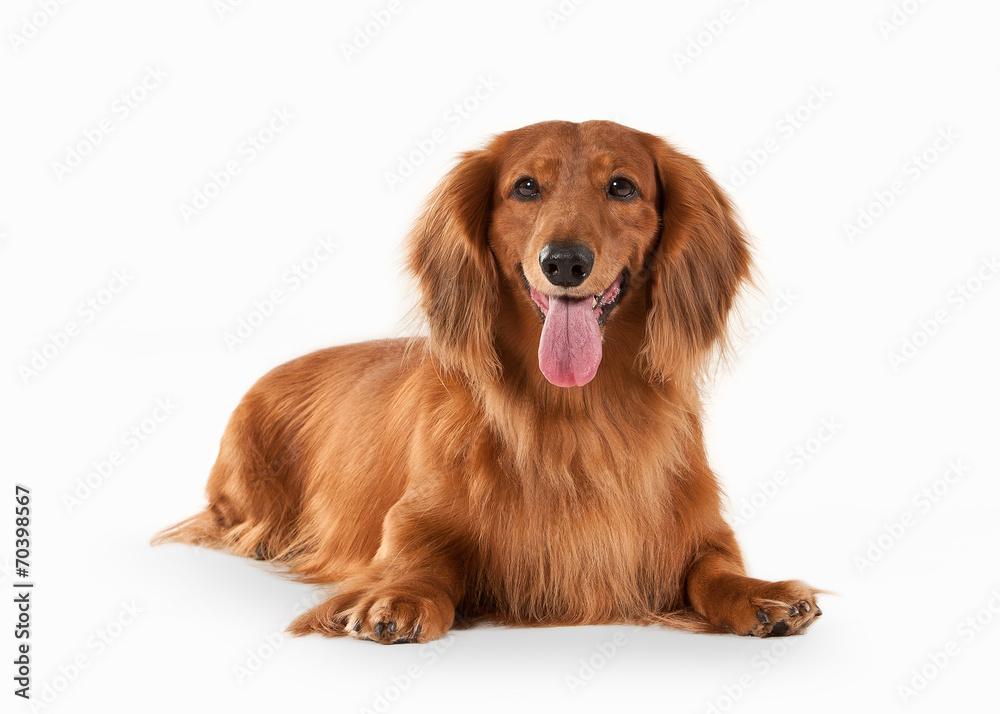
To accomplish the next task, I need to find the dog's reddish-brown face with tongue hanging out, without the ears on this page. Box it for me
[489,122,660,387]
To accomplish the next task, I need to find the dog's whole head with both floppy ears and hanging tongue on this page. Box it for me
[410,121,750,387]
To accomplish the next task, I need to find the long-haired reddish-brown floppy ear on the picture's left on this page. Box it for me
[409,150,500,381]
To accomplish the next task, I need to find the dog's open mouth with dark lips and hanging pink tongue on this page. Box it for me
[518,266,628,387]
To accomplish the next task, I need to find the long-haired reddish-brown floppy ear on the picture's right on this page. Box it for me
[642,137,752,381]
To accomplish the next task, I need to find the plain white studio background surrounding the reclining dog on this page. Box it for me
[0,0,1000,712]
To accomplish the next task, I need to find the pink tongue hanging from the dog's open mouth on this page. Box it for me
[538,295,601,387]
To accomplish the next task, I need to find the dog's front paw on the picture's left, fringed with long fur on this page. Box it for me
[288,593,455,645]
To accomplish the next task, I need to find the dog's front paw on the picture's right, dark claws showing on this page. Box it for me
[705,577,823,637]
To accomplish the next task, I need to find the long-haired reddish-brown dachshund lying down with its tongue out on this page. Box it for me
[157,121,821,643]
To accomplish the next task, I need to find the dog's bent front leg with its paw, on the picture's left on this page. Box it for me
[288,494,467,644]
